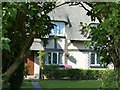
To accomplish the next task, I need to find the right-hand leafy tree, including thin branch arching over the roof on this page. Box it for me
[73,2,120,89]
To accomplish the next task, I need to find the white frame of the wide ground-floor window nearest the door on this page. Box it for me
[45,52,64,65]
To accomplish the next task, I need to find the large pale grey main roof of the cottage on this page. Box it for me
[48,4,98,40]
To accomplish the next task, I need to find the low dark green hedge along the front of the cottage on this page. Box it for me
[43,65,111,80]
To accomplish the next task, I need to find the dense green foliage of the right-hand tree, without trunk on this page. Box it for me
[91,2,120,69]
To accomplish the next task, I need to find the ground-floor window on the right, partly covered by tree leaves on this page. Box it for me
[91,52,100,66]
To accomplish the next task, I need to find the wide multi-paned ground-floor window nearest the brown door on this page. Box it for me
[45,52,63,65]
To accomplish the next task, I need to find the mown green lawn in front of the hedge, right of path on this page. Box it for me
[39,80,101,90]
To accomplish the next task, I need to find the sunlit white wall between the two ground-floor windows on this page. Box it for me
[68,41,90,69]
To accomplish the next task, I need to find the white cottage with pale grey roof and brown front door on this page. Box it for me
[26,4,112,78]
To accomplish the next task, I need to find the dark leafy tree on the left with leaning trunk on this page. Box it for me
[2,2,55,90]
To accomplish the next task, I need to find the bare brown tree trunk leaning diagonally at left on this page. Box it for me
[3,32,35,82]
